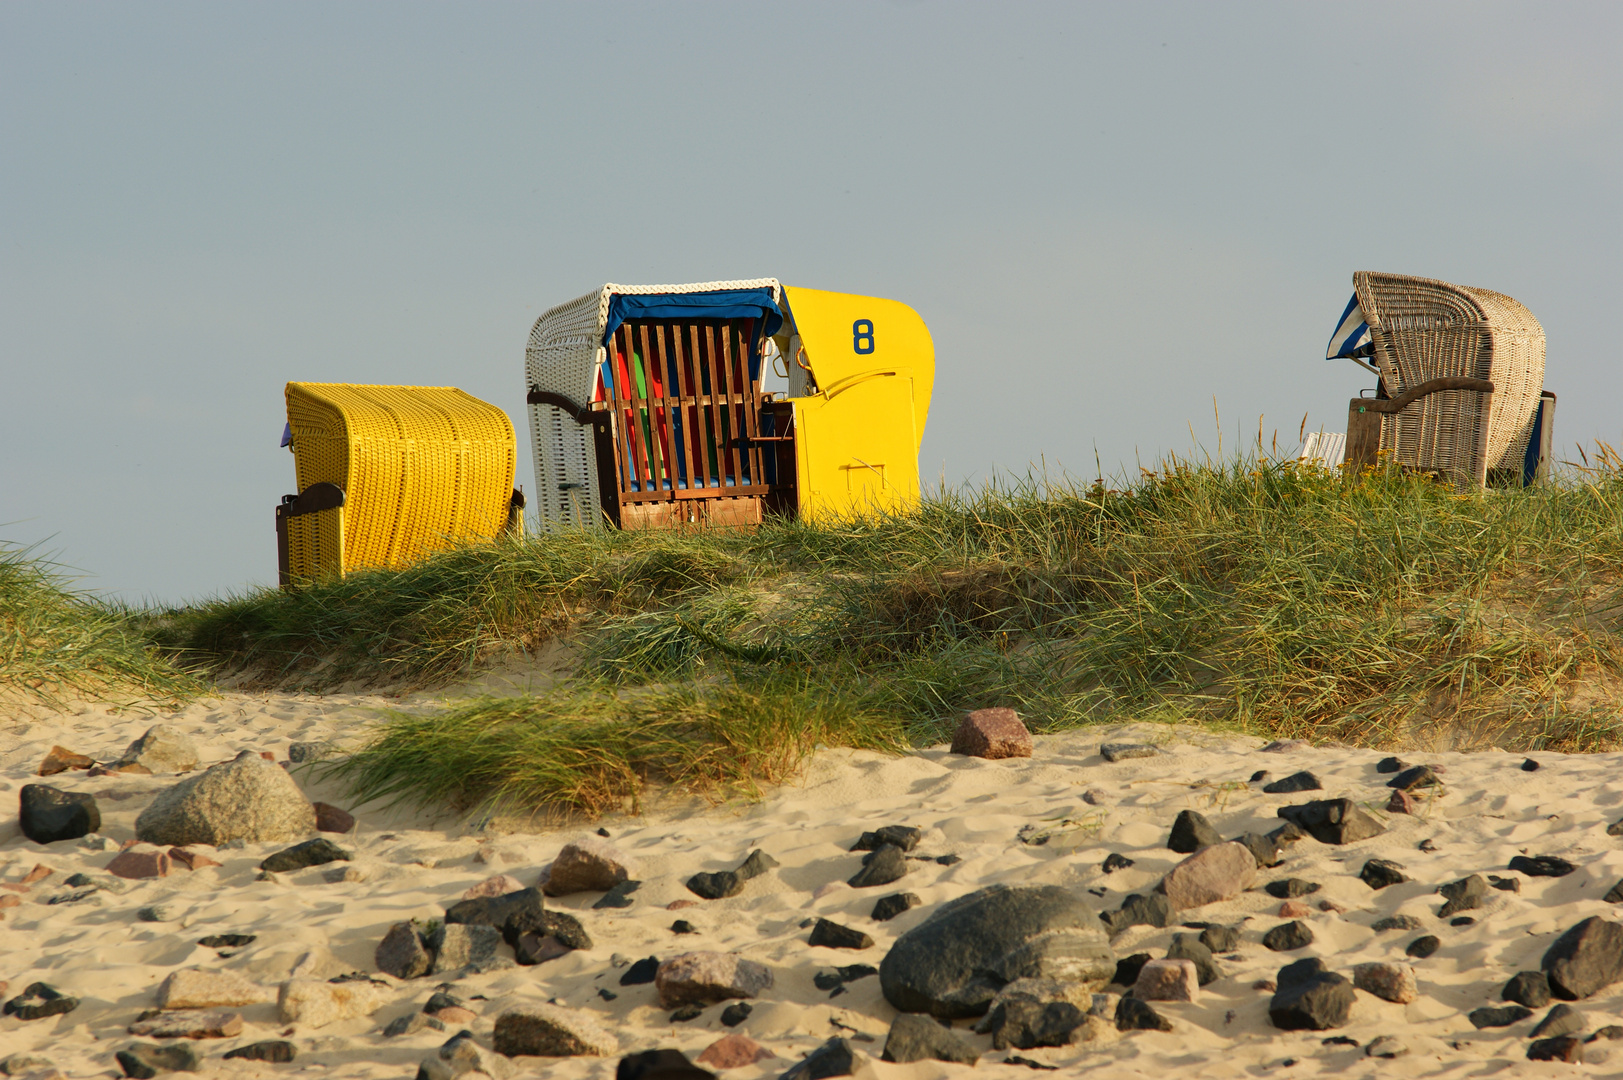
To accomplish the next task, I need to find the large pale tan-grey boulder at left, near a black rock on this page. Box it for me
[135,750,315,848]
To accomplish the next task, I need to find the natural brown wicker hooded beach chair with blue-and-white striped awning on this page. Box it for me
[1326,271,1555,487]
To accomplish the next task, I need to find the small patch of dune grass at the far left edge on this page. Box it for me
[0,541,201,703]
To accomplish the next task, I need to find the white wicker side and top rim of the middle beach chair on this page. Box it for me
[524,278,782,533]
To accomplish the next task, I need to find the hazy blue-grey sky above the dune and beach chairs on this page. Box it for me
[0,0,1623,604]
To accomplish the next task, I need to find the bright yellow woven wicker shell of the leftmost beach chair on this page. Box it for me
[287,383,518,577]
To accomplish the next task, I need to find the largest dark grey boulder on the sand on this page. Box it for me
[880,885,1115,1020]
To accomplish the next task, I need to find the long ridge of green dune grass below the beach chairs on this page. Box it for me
[166,456,1623,810]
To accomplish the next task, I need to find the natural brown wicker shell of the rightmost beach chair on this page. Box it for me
[1352,271,1543,484]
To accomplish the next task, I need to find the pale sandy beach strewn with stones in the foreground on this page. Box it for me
[0,693,1623,1080]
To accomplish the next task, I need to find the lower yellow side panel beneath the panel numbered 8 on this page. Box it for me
[792,372,919,521]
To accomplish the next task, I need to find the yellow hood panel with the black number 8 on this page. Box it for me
[784,286,935,444]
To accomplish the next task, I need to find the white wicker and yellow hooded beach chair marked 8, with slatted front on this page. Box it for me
[524,278,935,529]
